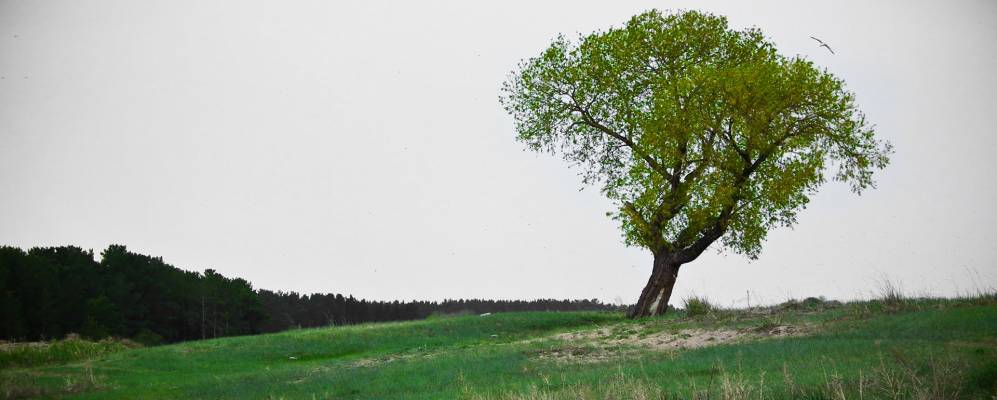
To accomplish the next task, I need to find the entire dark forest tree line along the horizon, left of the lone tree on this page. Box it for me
[0,245,616,344]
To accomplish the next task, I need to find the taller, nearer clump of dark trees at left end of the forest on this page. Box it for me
[0,245,264,344]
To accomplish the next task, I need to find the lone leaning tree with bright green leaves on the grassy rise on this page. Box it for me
[501,11,892,317]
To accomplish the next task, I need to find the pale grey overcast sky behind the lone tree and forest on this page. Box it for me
[0,0,997,306]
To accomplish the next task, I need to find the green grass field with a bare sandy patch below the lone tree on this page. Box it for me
[0,295,997,399]
